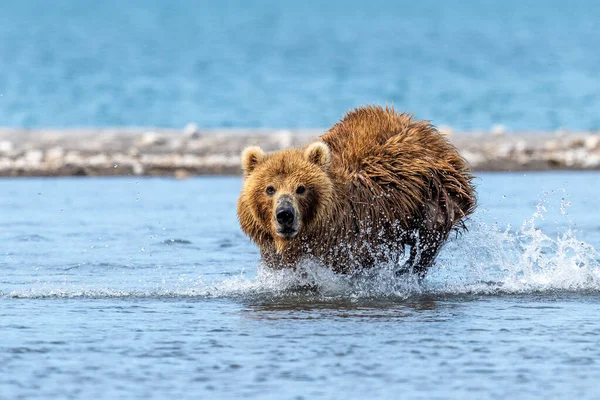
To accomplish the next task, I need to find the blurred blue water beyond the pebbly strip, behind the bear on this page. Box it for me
[0,0,600,130]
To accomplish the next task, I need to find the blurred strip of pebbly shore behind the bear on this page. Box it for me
[0,125,600,178]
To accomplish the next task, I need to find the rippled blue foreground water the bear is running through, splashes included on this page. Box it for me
[0,173,600,399]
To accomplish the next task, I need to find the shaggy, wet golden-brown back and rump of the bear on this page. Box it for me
[320,106,475,236]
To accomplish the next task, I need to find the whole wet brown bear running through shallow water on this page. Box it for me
[237,106,476,277]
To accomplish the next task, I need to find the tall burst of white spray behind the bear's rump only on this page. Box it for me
[428,217,600,294]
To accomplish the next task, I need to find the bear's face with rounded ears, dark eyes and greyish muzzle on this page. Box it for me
[238,142,333,241]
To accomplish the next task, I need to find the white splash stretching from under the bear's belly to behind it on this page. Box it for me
[190,190,600,298]
